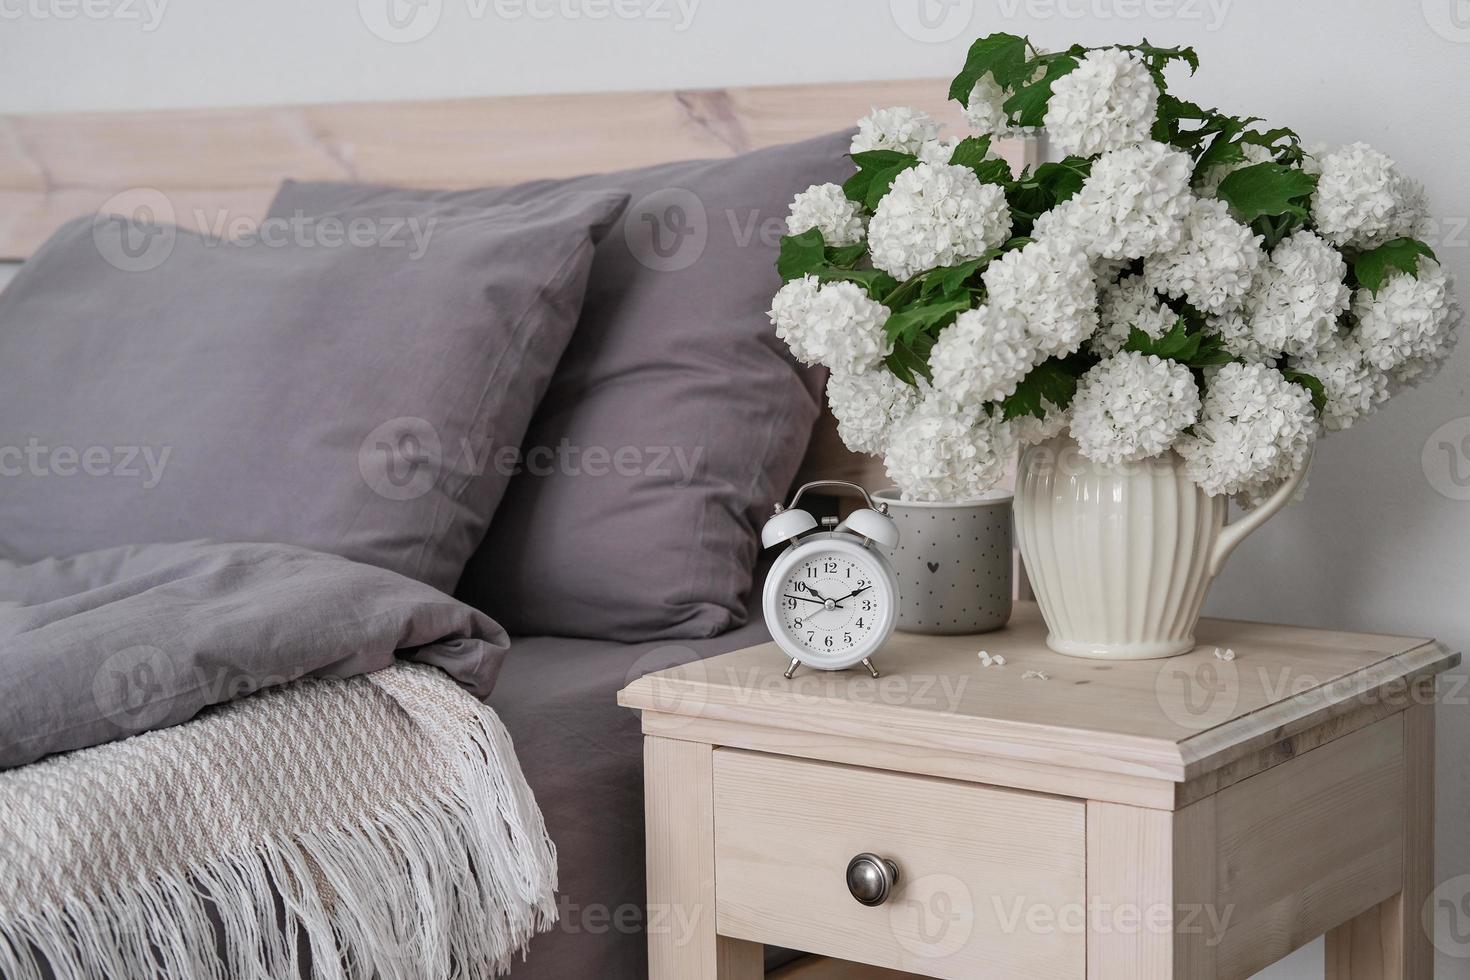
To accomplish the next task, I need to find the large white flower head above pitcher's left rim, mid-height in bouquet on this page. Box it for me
[980,238,1098,361]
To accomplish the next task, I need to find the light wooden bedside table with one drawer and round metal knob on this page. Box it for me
[619,602,1460,980]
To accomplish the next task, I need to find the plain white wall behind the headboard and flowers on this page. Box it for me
[0,0,1470,980]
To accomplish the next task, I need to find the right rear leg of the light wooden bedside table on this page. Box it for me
[1326,702,1435,980]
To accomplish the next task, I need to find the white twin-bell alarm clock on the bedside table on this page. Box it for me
[760,480,898,679]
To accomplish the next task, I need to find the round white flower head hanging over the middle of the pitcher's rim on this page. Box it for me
[1072,351,1200,463]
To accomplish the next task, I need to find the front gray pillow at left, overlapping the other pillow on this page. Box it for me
[0,191,628,591]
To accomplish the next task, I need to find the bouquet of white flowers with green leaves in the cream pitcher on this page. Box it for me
[770,34,1460,500]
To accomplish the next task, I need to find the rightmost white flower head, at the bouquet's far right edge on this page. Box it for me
[1352,257,1460,372]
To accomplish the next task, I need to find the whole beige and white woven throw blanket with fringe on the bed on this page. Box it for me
[0,664,556,980]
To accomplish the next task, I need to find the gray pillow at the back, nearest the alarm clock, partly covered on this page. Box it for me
[270,134,851,641]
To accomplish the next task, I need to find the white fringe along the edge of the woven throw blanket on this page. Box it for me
[0,690,557,980]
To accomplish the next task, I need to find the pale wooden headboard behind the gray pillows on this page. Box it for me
[0,79,1032,488]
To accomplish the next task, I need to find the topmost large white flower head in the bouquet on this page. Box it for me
[1044,48,1158,157]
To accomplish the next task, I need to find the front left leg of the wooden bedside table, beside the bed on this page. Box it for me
[644,736,764,980]
